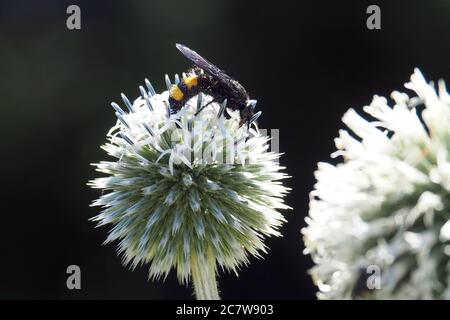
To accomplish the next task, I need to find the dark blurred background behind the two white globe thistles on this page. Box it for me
[0,0,450,299]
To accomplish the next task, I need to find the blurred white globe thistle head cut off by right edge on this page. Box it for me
[302,69,450,299]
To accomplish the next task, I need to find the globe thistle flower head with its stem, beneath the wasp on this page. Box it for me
[90,76,288,299]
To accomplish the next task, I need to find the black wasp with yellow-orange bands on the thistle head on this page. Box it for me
[169,44,261,126]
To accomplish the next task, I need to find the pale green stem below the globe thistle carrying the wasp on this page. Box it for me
[191,253,220,300]
